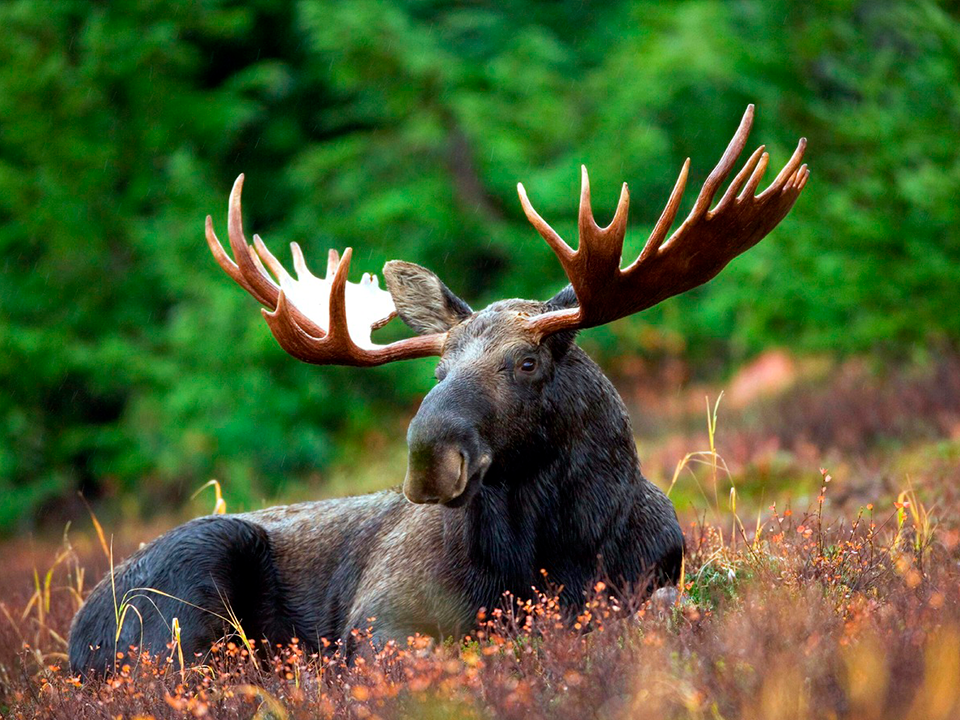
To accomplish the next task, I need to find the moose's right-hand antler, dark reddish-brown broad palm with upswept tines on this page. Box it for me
[517,105,810,335]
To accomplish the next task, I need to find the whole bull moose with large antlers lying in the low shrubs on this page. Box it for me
[69,105,809,676]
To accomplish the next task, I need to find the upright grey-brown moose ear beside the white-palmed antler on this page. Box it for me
[383,260,473,335]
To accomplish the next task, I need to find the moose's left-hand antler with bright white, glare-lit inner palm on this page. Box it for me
[207,175,445,366]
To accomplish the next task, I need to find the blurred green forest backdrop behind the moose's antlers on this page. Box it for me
[0,0,960,531]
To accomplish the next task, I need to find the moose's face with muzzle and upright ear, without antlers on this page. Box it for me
[384,262,569,507]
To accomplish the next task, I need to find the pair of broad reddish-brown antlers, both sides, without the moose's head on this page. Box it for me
[207,105,810,366]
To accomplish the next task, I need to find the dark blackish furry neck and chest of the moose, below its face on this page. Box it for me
[447,346,641,602]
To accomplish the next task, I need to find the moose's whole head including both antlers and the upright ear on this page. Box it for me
[206,105,809,506]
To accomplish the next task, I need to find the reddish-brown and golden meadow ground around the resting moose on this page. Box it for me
[0,353,960,720]
